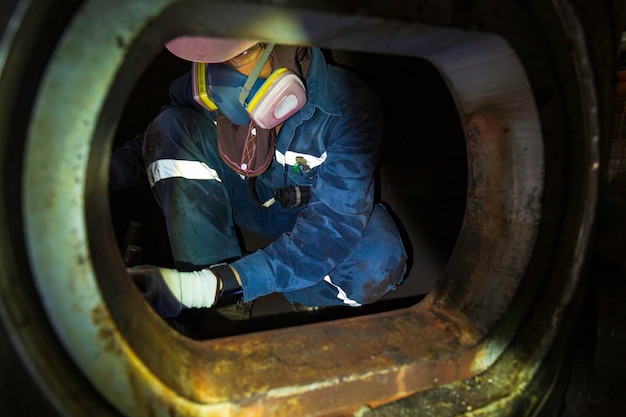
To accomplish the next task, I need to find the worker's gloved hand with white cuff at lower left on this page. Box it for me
[128,265,221,317]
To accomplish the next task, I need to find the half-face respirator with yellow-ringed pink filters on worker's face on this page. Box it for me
[191,44,306,129]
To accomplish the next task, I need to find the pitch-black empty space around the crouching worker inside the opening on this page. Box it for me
[111,45,467,338]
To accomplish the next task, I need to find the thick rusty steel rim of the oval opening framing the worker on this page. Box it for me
[1,0,608,417]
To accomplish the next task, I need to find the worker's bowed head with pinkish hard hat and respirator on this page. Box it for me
[166,37,306,129]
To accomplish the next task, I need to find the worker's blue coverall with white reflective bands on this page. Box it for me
[143,48,406,306]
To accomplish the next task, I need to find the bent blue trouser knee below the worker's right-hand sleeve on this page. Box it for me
[284,205,407,306]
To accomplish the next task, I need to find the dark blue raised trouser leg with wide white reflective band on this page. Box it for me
[143,107,241,270]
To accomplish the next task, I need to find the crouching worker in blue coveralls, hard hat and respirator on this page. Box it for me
[121,37,406,317]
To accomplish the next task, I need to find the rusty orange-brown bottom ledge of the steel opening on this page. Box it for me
[152,304,485,415]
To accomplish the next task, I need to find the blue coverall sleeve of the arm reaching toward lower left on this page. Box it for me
[232,77,383,301]
